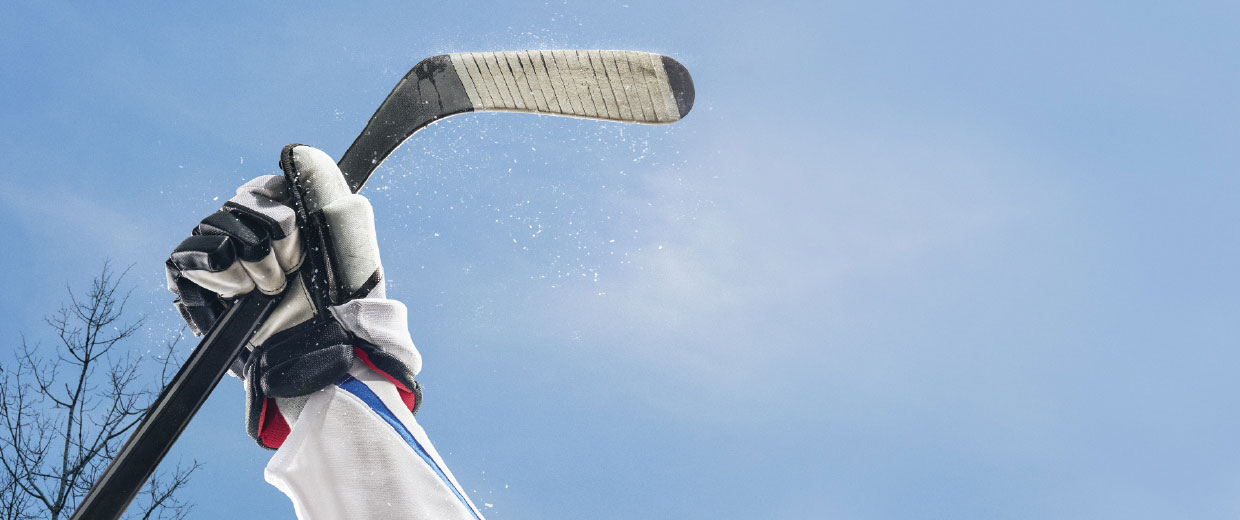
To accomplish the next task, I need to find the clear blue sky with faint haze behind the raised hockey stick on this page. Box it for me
[0,0,1240,519]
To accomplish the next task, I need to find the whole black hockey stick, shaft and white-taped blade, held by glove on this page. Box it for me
[73,51,694,520]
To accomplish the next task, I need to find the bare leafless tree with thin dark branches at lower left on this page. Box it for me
[0,263,198,520]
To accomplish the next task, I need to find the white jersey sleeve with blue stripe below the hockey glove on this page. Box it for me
[265,361,482,520]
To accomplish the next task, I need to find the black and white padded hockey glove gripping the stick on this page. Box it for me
[166,144,422,448]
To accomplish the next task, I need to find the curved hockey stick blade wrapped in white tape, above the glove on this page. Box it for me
[340,51,694,192]
